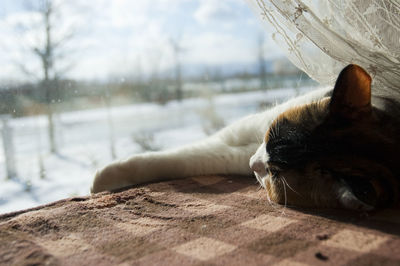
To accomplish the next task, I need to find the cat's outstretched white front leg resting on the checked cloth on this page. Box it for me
[91,138,257,193]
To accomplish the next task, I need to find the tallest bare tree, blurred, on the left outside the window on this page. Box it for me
[18,0,74,153]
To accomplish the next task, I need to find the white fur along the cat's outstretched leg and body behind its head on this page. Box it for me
[92,88,329,193]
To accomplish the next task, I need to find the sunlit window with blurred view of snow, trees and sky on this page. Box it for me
[0,0,316,213]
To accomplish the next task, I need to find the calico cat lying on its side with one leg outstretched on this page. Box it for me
[92,65,400,210]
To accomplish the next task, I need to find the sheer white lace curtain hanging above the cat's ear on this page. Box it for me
[248,0,400,96]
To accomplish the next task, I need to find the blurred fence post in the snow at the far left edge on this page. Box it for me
[0,115,17,179]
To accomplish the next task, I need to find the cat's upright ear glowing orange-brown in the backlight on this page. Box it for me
[329,65,372,119]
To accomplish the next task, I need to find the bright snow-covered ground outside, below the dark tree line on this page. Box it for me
[0,88,318,213]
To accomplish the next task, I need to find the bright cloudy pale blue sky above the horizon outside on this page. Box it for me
[0,0,282,83]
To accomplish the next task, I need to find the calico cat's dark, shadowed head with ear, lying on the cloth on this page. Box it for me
[250,65,399,210]
